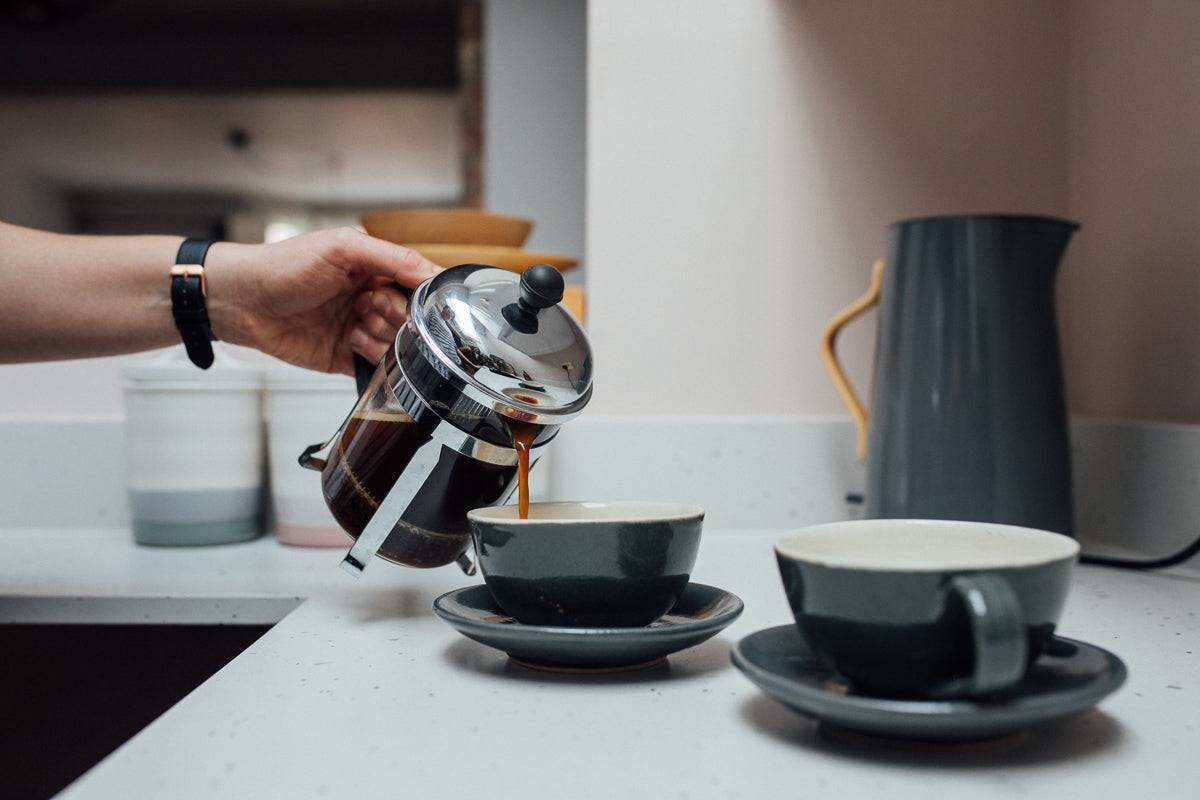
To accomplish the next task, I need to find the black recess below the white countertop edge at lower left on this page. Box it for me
[0,625,269,800]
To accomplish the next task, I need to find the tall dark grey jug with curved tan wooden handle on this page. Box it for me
[822,215,1079,535]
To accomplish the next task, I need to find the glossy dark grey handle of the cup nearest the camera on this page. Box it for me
[950,573,1028,694]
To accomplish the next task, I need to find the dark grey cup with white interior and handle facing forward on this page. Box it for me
[775,519,1079,698]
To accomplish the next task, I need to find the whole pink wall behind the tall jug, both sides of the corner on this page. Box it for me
[588,0,1200,422]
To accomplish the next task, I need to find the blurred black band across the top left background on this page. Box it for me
[0,0,460,92]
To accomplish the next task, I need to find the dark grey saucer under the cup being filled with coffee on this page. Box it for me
[433,583,743,672]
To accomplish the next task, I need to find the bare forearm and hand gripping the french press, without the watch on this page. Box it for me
[0,223,438,373]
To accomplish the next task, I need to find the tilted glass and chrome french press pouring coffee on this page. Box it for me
[300,264,592,576]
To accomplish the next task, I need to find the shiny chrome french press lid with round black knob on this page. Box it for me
[409,264,592,421]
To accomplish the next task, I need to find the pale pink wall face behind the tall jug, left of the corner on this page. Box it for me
[588,0,1069,415]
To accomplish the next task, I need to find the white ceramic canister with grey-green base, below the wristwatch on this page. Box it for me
[124,343,264,545]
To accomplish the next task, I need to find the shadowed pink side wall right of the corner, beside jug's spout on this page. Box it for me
[1060,0,1200,422]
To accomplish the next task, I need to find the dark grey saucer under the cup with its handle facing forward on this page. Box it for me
[732,625,1126,740]
